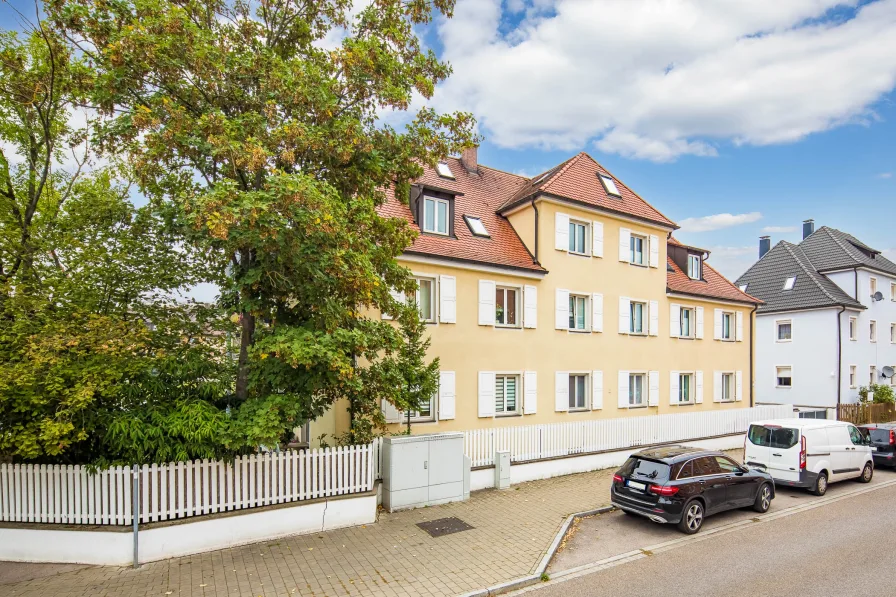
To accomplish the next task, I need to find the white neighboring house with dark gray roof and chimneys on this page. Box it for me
[736,220,896,416]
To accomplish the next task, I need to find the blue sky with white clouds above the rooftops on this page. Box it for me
[0,0,896,286]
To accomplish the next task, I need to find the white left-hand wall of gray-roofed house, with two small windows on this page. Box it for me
[756,309,845,406]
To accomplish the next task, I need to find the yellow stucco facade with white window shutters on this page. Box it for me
[311,198,753,437]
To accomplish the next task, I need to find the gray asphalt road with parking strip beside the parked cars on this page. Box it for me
[519,471,896,597]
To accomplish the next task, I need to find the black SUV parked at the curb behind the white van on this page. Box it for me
[610,446,775,535]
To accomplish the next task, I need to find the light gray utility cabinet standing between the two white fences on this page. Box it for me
[383,433,470,512]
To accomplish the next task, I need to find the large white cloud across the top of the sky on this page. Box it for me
[434,0,896,161]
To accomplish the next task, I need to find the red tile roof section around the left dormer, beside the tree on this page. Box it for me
[380,158,545,272]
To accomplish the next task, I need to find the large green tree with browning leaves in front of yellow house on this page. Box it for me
[47,0,474,448]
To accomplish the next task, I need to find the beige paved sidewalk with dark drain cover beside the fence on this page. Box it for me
[0,470,612,597]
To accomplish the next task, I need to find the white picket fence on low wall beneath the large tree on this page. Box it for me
[0,444,379,525]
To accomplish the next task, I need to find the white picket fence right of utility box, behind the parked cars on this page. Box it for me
[464,405,794,467]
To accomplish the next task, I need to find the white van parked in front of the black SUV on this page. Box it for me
[744,419,874,495]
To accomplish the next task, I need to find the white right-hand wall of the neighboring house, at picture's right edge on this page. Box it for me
[828,270,896,402]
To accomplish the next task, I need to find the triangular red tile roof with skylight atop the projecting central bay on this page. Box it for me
[501,152,677,228]
